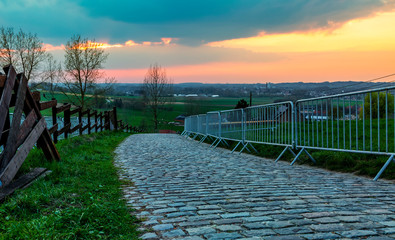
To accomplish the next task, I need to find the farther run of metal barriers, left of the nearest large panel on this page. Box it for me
[184,102,296,158]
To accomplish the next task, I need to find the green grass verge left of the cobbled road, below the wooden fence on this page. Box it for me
[0,131,138,239]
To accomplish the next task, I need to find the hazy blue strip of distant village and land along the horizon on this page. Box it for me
[111,81,394,100]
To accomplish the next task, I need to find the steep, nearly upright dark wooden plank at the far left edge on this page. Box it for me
[0,66,16,141]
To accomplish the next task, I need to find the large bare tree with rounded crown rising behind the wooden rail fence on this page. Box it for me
[62,35,115,109]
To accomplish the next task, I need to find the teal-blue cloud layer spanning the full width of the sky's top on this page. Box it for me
[0,0,395,45]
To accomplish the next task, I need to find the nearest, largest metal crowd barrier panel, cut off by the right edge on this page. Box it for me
[291,87,395,180]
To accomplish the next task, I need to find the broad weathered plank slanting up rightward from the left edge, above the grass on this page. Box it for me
[0,118,46,186]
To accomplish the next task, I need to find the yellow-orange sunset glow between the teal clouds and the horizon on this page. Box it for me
[44,11,395,83]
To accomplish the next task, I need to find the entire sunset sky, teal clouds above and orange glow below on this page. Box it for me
[0,0,395,83]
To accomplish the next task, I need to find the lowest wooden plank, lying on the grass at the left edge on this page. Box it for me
[0,168,47,202]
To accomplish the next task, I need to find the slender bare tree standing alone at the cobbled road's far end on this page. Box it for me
[143,64,172,130]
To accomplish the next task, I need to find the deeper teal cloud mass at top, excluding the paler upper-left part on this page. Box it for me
[74,0,394,43]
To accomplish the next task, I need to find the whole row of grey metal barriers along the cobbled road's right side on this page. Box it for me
[183,87,395,180]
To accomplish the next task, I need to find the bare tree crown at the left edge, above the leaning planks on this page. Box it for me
[0,27,48,88]
